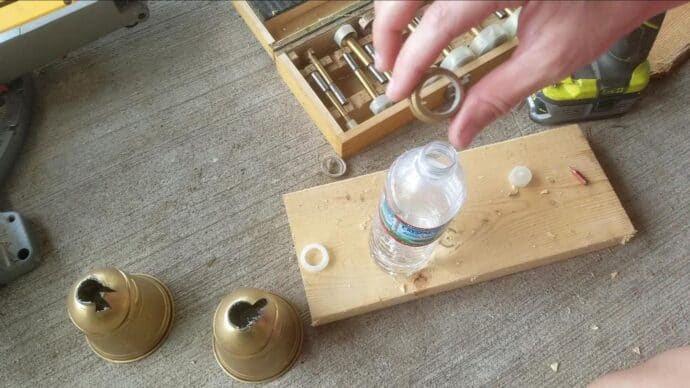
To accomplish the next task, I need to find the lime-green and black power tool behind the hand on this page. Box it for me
[527,13,665,124]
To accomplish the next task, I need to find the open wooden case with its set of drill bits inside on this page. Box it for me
[232,0,518,158]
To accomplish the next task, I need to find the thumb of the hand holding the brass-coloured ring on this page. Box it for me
[448,49,565,148]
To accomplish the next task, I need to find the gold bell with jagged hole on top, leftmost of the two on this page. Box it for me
[67,268,174,363]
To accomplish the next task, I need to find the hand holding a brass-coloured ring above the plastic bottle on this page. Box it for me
[373,0,683,148]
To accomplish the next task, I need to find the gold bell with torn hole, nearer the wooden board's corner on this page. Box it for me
[213,288,304,383]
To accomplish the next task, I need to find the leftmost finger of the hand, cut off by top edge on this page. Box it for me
[372,0,424,71]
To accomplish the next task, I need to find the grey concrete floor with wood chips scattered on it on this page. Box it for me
[0,1,690,387]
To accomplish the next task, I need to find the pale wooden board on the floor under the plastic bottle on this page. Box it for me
[284,125,635,326]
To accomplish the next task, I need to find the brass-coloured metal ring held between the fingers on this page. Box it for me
[409,67,462,123]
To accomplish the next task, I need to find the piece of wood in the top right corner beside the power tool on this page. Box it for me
[649,3,690,77]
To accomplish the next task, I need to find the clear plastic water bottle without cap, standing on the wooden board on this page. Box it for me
[369,141,467,275]
